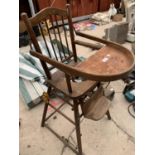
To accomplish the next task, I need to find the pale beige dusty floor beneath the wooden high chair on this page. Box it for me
[19,20,135,155]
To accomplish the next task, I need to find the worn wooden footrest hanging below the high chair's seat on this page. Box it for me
[81,87,110,121]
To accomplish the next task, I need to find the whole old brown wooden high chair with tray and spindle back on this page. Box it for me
[22,5,134,155]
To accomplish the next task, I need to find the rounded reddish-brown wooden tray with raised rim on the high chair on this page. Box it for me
[76,44,134,81]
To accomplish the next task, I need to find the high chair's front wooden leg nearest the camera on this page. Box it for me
[74,101,82,155]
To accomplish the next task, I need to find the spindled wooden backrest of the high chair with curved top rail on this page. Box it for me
[21,4,77,79]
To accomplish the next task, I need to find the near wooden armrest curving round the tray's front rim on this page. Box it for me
[30,48,134,81]
